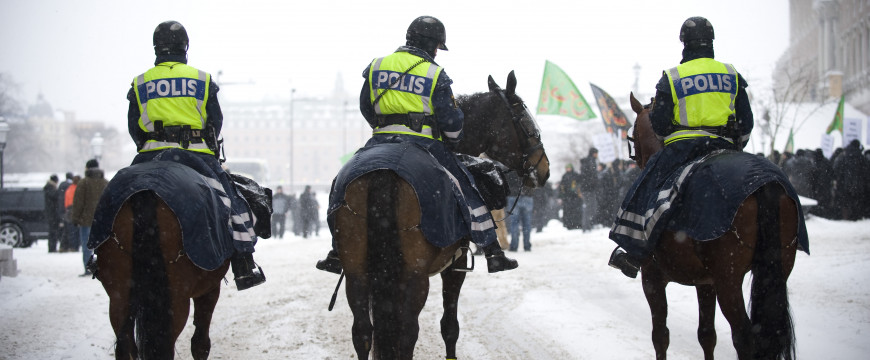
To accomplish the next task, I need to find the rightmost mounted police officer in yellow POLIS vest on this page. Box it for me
[609,16,753,278]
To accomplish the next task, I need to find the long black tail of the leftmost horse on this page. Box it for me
[129,191,175,360]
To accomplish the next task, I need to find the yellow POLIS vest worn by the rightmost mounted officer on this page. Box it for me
[665,58,738,145]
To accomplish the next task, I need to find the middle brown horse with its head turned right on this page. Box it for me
[335,72,549,360]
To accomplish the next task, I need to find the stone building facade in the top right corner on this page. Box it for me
[774,0,870,113]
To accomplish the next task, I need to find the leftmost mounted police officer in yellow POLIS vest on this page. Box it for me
[127,21,266,290]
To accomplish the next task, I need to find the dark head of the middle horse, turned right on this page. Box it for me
[482,71,550,188]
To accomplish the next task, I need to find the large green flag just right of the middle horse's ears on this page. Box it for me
[537,61,595,120]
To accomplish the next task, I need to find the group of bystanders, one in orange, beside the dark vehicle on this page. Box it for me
[42,159,108,276]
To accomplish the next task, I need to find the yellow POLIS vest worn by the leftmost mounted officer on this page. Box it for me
[134,62,214,154]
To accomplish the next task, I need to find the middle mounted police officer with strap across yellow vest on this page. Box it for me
[317,16,518,273]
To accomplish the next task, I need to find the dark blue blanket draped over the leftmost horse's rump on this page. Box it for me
[88,161,235,271]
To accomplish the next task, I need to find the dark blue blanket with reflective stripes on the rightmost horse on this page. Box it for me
[610,150,809,256]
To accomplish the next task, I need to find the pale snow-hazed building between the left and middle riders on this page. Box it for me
[221,92,371,193]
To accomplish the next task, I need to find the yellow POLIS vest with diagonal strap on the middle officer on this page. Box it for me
[368,52,442,139]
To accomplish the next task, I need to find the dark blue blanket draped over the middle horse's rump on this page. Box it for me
[326,142,471,247]
